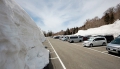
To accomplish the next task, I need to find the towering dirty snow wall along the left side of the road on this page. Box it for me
[0,0,49,69]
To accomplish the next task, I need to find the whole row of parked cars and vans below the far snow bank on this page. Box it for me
[53,35,120,54]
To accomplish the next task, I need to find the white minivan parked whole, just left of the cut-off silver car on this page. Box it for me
[83,37,107,47]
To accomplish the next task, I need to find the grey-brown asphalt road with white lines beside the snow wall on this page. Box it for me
[43,38,120,69]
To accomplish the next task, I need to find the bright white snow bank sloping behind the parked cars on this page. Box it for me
[75,20,120,37]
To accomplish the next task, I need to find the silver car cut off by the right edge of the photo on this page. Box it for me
[106,36,120,54]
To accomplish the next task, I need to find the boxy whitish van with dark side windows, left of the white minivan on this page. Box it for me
[67,35,83,43]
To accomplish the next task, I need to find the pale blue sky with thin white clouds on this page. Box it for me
[15,0,120,32]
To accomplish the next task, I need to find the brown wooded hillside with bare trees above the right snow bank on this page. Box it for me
[79,4,120,30]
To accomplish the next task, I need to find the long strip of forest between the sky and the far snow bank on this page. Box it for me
[43,3,120,37]
